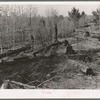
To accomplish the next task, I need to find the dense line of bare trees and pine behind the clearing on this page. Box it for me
[0,5,94,53]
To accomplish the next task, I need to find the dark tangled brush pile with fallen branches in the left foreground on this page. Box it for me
[0,42,68,89]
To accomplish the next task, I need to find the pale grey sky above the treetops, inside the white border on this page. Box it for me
[38,4,99,16]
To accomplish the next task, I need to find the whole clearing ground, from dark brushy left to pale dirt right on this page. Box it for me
[0,37,100,89]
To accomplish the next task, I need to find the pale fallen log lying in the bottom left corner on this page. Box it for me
[1,80,36,89]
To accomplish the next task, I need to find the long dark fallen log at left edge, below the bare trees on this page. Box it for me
[0,45,31,59]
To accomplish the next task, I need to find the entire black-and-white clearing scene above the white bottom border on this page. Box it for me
[0,2,100,89]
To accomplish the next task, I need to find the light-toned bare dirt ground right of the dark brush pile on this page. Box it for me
[43,38,100,89]
